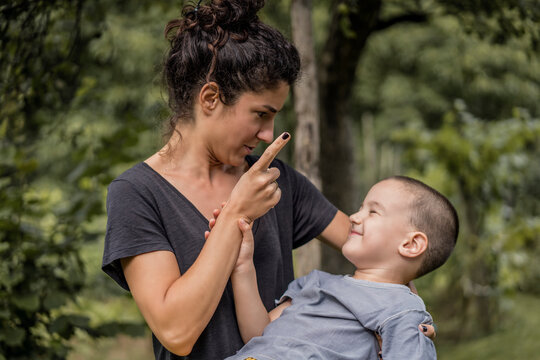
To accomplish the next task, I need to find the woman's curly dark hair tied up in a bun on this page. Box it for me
[163,0,300,137]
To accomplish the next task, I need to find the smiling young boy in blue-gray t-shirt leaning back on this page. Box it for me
[221,176,459,360]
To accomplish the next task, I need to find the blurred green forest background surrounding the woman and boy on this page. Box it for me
[0,0,540,360]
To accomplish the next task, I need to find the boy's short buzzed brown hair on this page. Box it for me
[387,176,459,277]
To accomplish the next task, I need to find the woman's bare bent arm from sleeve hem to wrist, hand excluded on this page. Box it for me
[122,210,242,355]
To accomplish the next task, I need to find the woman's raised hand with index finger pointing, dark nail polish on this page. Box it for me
[227,133,291,223]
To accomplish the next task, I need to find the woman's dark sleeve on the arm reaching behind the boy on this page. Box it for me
[292,166,337,248]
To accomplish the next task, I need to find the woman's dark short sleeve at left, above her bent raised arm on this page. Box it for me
[102,180,173,290]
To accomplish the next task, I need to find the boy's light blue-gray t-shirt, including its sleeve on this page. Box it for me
[227,270,437,360]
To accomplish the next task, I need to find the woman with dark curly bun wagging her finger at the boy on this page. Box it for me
[103,0,430,360]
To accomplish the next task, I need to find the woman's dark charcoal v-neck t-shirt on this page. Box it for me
[102,156,337,360]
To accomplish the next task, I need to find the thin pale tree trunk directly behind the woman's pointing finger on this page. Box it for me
[291,0,321,276]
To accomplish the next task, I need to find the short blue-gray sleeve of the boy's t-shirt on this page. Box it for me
[377,310,437,360]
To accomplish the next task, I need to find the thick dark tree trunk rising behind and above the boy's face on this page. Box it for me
[319,0,381,273]
